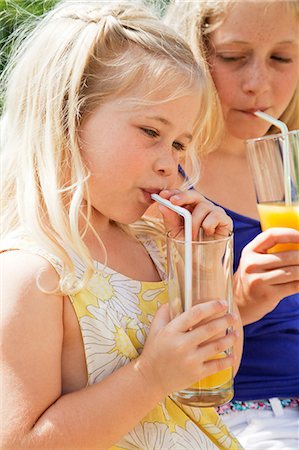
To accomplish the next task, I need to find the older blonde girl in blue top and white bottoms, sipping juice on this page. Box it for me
[167,0,299,450]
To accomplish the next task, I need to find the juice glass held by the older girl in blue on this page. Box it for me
[245,130,299,252]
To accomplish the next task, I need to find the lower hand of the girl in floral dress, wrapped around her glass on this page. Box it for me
[137,301,237,397]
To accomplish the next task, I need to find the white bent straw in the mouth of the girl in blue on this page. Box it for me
[254,111,292,206]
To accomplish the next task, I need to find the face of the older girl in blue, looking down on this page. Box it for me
[210,1,299,140]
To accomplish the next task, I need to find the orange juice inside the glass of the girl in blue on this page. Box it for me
[258,202,299,253]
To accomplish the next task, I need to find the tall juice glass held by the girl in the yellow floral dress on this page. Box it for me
[167,228,234,407]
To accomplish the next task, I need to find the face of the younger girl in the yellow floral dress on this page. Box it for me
[79,82,200,224]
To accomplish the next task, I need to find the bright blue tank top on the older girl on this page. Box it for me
[220,208,299,400]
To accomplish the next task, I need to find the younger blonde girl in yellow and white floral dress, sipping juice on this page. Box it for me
[0,1,241,450]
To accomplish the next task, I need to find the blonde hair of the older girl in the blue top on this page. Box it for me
[165,0,299,134]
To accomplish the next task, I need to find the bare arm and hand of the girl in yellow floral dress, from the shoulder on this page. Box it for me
[0,252,235,450]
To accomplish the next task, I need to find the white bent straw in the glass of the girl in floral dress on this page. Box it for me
[151,194,192,311]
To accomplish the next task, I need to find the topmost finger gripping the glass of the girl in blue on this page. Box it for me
[248,228,299,253]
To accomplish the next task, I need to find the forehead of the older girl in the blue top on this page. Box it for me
[212,0,299,43]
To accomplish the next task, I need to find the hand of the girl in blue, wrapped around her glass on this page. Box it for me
[234,228,299,325]
